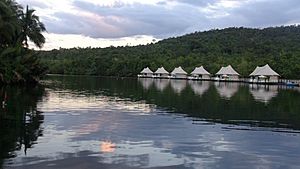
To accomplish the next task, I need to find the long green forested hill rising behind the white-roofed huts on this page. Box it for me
[39,26,300,79]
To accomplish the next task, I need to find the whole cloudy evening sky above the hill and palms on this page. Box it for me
[17,0,300,50]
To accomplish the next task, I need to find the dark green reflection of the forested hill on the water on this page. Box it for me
[45,76,300,129]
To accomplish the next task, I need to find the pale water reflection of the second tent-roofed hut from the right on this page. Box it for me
[215,82,239,99]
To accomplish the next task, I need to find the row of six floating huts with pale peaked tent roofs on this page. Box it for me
[138,64,299,85]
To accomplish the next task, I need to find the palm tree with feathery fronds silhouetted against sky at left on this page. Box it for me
[19,5,46,48]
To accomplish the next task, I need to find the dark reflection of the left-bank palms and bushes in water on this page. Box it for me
[0,86,44,166]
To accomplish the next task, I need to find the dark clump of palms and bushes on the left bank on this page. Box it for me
[0,0,46,85]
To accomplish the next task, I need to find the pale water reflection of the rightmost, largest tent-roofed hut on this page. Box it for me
[250,85,278,103]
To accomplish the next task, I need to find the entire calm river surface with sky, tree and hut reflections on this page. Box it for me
[0,76,300,169]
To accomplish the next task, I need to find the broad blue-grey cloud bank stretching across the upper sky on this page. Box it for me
[44,0,300,38]
